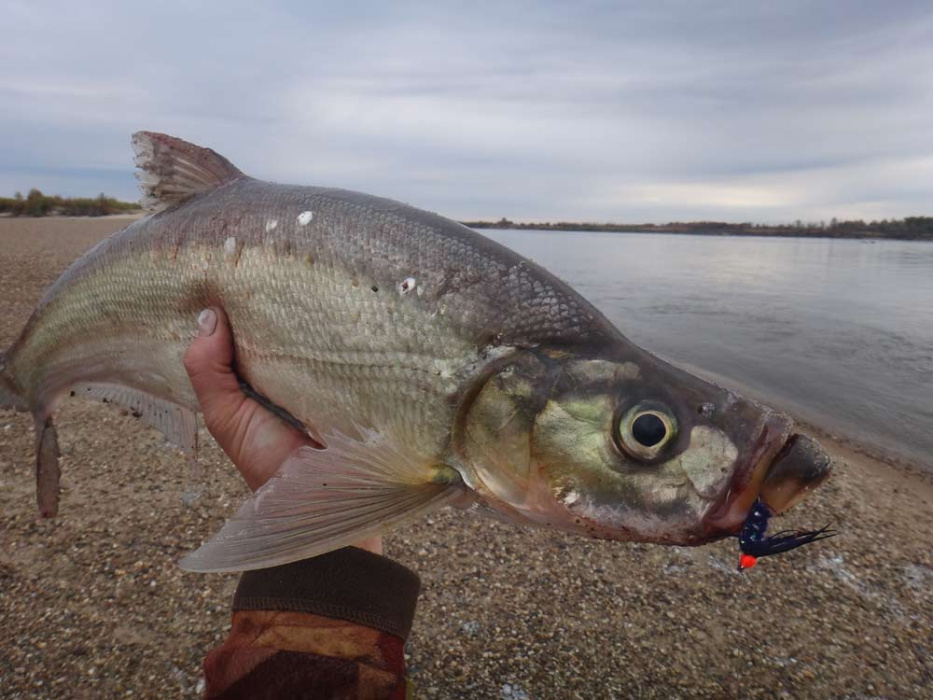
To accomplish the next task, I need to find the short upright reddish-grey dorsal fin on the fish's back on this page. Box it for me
[133,131,245,211]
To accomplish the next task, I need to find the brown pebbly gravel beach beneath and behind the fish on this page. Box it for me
[0,218,933,700]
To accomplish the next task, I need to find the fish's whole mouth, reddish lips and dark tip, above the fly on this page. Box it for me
[702,413,833,538]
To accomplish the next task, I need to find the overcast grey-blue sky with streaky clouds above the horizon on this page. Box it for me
[0,0,933,223]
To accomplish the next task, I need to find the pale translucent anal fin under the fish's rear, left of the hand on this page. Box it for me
[72,383,198,458]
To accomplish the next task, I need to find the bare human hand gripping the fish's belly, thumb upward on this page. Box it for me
[184,308,382,554]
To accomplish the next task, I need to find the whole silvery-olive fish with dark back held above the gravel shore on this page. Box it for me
[0,131,832,572]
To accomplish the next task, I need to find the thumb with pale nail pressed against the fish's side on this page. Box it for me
[184,308,247,445]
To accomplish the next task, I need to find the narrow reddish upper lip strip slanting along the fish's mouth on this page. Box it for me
[701,411,792,537]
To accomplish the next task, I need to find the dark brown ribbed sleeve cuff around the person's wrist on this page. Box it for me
[233,547,421,639]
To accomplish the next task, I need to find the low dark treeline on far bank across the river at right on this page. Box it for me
[462,216,933,240]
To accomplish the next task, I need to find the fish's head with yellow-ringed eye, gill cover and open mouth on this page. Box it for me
[459,345,832,545]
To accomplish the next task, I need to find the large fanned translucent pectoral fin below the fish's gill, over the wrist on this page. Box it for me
[180,430,464,572]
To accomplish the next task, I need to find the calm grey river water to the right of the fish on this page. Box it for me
[481,230,933,470]
